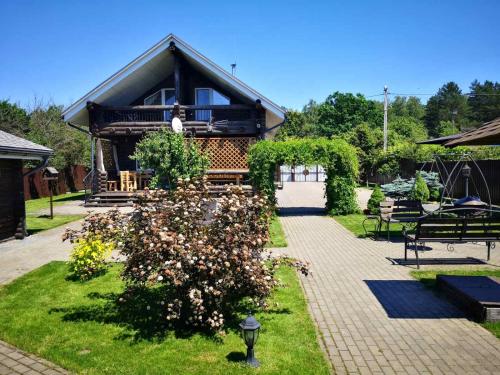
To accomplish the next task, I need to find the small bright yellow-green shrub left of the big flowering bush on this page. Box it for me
[69,238,114,280]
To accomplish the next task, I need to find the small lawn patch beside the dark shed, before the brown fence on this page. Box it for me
[26,192,85,234]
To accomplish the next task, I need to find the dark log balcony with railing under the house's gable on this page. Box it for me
[87,102,265,136]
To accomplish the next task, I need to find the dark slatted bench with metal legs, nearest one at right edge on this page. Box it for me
[403,208,500,268]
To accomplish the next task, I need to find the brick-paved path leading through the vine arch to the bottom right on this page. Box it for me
[278,183,500,374]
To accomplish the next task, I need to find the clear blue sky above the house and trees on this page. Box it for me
[0,0,500,108]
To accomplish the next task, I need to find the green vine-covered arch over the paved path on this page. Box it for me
[248,138,358,215]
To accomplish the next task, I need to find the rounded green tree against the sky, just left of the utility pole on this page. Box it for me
[317,91,383,137]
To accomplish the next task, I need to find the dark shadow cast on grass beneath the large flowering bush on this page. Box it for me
[49,286,291,342]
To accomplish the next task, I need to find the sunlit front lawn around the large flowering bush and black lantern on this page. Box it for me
[0,262,329,374]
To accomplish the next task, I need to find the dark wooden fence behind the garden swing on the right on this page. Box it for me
[368,160,500,205]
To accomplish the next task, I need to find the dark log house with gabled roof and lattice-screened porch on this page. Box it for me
[63,34,285,204]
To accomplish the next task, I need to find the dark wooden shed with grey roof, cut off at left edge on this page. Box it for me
[0,130,53,241]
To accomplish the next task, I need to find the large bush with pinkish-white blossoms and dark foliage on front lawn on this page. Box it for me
[66,179,307,330]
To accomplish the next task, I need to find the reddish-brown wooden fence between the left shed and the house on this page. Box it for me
[23,165,88,200]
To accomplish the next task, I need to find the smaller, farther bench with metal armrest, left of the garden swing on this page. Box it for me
[377,199,424,241]
